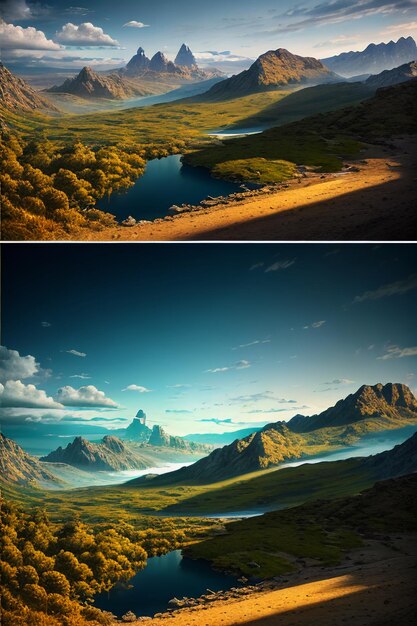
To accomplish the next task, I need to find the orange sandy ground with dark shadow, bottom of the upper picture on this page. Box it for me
[77,138,417,241]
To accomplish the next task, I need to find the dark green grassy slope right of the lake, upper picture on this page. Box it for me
[186,81,417,182]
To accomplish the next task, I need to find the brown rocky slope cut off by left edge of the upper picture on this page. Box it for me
[0,63,58,111]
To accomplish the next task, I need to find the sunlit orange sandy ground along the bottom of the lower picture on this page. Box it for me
[135,535,417,626]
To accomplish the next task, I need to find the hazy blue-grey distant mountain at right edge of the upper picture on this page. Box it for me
[321,37,417,77]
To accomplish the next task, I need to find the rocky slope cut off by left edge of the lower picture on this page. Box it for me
[0,433,60,484]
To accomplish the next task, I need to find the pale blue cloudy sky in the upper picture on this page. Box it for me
[0,0,417,73]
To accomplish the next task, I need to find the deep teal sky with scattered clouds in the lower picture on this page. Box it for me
[0,244,417,435]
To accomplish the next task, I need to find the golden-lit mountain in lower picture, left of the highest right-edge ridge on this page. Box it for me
[131,422,304,485]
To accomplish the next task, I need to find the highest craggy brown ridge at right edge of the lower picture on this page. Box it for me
[288,383,417,433]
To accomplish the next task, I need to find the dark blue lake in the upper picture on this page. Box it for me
[97,154,250,221]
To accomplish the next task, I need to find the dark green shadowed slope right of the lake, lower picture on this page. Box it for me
[187,474,417,578]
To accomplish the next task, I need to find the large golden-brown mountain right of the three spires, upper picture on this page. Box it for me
[201,48,339,100]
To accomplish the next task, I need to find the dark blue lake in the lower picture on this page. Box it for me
[94,550,238,617]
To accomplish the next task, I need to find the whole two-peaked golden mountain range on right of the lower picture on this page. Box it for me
[132,383,417,485]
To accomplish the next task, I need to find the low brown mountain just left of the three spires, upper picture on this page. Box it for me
[47,67,152,100]
